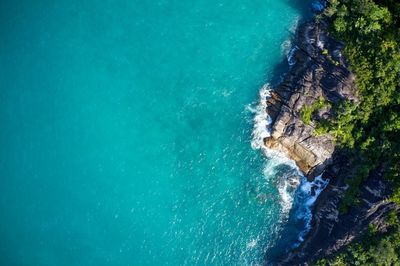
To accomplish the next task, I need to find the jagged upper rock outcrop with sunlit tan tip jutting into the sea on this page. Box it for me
[265,20,357,178]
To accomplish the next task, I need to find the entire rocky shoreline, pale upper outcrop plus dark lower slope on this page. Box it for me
[264,11,397,265]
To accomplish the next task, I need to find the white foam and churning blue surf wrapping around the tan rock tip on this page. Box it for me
[250,84,329,246]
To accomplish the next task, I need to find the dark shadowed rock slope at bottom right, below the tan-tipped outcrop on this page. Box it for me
[280,151,399,265]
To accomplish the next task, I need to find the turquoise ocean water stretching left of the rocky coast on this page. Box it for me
[0,0,309,266]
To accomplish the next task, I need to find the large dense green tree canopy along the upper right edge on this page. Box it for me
[317,0,400,211]
